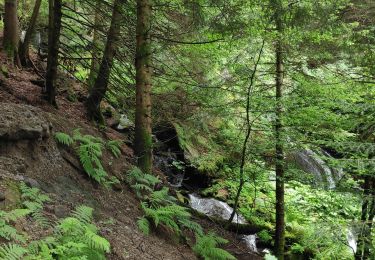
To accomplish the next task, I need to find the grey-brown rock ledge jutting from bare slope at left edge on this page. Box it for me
[0,103,52,141]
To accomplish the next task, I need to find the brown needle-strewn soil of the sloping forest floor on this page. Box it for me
[0,41,261,259]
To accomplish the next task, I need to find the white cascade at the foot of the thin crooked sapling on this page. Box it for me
[189,194,247,224]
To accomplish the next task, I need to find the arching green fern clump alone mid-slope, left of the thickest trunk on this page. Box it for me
[55,129,121,187]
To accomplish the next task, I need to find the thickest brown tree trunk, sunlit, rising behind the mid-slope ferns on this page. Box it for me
[134,0,152,173]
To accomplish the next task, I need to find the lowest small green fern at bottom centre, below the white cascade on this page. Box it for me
[193,233,236,260]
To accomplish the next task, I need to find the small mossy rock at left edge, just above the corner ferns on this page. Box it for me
[0,179,22,211]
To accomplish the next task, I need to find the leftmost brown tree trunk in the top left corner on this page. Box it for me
[3,0,20,65]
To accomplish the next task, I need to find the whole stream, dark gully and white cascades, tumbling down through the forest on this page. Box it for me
[154,126,357,255]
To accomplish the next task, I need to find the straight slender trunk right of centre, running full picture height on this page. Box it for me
[273,0,285,260]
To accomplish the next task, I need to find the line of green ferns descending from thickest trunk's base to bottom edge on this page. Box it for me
[127,168,236,260]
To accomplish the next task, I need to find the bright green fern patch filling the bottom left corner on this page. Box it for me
[0,183,110,260]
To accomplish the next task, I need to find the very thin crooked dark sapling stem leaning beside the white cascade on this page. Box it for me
[228,40,264,223]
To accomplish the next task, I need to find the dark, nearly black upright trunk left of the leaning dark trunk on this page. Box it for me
[45,0,62,107]
